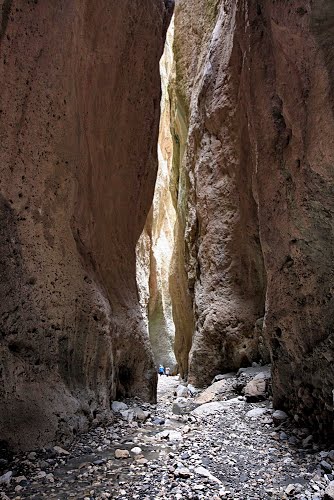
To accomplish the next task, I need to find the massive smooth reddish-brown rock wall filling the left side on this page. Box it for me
[0,0,172,448]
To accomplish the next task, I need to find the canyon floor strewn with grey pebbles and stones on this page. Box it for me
[0,374,334,500]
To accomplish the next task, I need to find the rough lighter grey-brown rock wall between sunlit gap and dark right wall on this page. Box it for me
[176,1,265,385]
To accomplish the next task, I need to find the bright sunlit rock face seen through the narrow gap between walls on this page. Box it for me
[137,17,177,372]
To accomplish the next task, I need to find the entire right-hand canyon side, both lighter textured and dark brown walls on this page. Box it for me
[175,0,334,436]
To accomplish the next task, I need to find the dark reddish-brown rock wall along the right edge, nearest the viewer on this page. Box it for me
[244,1,334,436]
